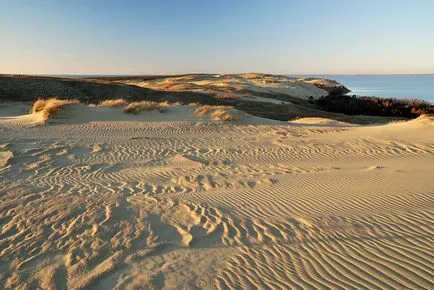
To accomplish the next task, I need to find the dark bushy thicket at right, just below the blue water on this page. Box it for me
[315,95,434,118]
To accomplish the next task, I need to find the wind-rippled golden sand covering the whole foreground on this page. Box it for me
[0,104,434,289]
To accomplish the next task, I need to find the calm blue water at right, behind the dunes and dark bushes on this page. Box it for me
[292,75,434,102]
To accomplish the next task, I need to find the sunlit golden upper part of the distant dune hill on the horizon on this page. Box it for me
[117,73,342,102]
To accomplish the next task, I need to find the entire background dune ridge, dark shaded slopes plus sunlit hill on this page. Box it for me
[0,74,402,124]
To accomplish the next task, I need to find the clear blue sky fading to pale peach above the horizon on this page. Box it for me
[0,0,434,74]
